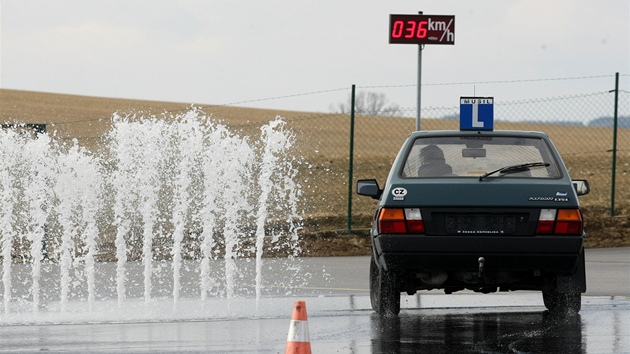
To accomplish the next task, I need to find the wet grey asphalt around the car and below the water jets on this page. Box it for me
[0,248,630,353]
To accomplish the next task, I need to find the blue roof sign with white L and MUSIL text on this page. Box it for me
[459,97,494,130]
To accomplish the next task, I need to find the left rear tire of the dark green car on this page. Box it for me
[370,258,400,316]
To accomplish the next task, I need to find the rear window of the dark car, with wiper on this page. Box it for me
[400,136,560,178]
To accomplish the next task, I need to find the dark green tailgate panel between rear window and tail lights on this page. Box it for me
[381,178,579,208]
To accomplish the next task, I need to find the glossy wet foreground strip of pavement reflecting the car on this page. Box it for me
[0,299,630,353]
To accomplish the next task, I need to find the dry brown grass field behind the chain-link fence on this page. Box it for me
[0,89,630,247]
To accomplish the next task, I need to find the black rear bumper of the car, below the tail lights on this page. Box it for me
[373,235,583,274]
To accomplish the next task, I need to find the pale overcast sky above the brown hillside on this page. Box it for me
[0,0,630,112]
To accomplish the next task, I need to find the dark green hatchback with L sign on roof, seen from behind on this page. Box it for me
[357,131,589,315]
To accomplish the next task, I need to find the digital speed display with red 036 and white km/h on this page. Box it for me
[389,14,455,44]
